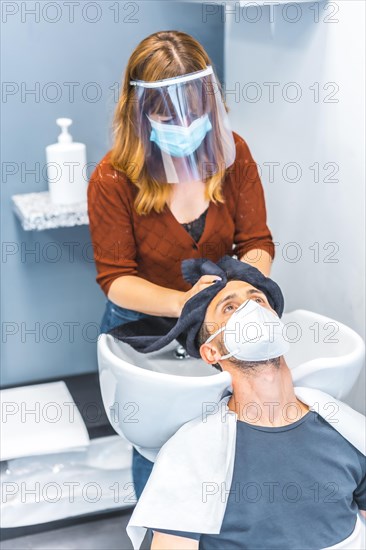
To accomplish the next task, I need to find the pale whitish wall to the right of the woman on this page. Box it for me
[225,0,365,411]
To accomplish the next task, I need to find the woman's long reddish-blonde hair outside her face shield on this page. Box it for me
[110,31,228,215]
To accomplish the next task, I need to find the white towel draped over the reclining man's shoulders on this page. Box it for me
[127,386,366,550]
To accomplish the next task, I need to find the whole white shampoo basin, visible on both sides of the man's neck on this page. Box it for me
[98,310,365,461]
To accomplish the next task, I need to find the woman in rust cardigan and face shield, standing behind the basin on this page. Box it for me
[88,31,274,497]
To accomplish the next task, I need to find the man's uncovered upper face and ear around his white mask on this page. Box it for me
[200,281,277,363]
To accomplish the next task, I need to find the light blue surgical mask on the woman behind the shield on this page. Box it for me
[148,113,212,157]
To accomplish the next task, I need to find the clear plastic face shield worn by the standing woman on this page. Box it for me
[130,66,235,183]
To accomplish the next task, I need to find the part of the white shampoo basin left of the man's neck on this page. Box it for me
[98,334,231,461]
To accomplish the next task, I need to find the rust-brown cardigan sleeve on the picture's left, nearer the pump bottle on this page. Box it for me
[87,163,137,296]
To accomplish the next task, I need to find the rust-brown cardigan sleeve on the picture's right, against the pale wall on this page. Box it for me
[234,137,275,259]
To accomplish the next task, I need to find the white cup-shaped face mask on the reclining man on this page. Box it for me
[205,300,290,361]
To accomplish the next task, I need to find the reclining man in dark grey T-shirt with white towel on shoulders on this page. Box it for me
[127,260,366,550]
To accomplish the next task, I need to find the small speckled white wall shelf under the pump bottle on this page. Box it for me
[11,191,89,231]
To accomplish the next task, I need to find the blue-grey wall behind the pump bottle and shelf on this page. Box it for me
[1,1,223,386]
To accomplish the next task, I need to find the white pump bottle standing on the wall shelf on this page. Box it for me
[46,118,88,204]
